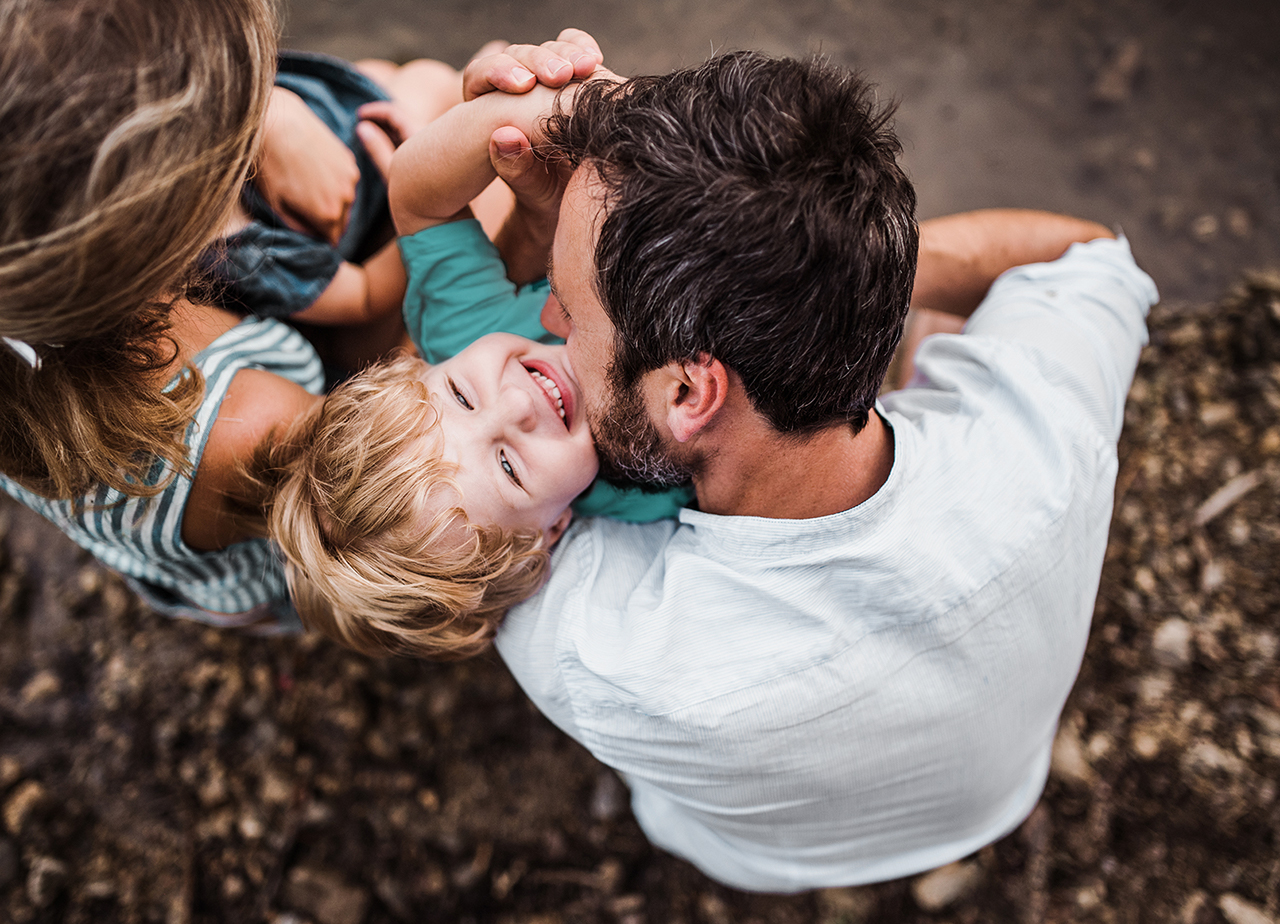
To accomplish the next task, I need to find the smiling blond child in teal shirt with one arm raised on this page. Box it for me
[269,64,690,658]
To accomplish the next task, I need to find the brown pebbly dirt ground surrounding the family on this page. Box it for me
[0,0,1280,924]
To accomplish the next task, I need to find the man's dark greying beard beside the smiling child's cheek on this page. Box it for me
[591,373,695,491]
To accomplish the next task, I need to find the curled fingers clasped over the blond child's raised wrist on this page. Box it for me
[462,28,604,100]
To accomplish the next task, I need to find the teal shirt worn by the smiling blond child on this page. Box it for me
[399,219,694,523]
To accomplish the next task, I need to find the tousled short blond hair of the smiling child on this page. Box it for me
[259,357,549,659]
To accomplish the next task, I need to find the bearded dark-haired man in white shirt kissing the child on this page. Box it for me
[476,54,1156,891]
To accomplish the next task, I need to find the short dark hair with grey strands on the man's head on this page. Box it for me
[548,51,918,435]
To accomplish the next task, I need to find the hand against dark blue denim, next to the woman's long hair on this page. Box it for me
[253,87,360,244]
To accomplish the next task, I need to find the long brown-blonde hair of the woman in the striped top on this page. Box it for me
[0,0,278,498]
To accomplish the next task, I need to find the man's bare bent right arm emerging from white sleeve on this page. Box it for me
[911,209,1115,317]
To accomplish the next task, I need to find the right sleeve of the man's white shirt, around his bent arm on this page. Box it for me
[964,237,1160,440]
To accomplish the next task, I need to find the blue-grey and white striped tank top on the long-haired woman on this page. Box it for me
[0,319,324,625]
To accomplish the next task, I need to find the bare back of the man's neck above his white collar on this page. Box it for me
[694,412,893,520]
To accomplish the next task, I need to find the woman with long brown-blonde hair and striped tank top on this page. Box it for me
[0,0,593,625]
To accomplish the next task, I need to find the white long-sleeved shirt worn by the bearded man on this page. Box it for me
[498,241,1157,892]
